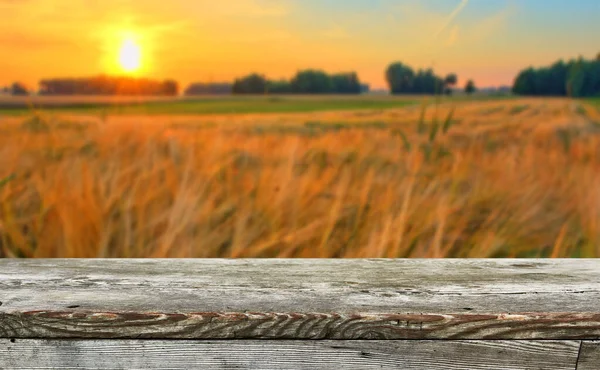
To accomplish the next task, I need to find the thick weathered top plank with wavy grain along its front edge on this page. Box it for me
[0,259,600,339]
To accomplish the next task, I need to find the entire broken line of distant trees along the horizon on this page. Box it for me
[3,54,600,97]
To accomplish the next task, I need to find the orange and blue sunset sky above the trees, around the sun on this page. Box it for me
[0,0,600,88]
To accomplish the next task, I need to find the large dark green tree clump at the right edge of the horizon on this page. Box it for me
[512,54,600,98]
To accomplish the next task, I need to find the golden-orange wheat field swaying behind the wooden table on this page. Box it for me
[0,99,600,258]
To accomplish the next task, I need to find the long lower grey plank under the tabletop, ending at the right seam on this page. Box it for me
[0,339,579,370]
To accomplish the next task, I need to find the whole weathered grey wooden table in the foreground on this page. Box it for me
[0,259,600,370]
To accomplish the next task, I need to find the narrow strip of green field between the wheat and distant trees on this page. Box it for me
[0,95,524,116]
